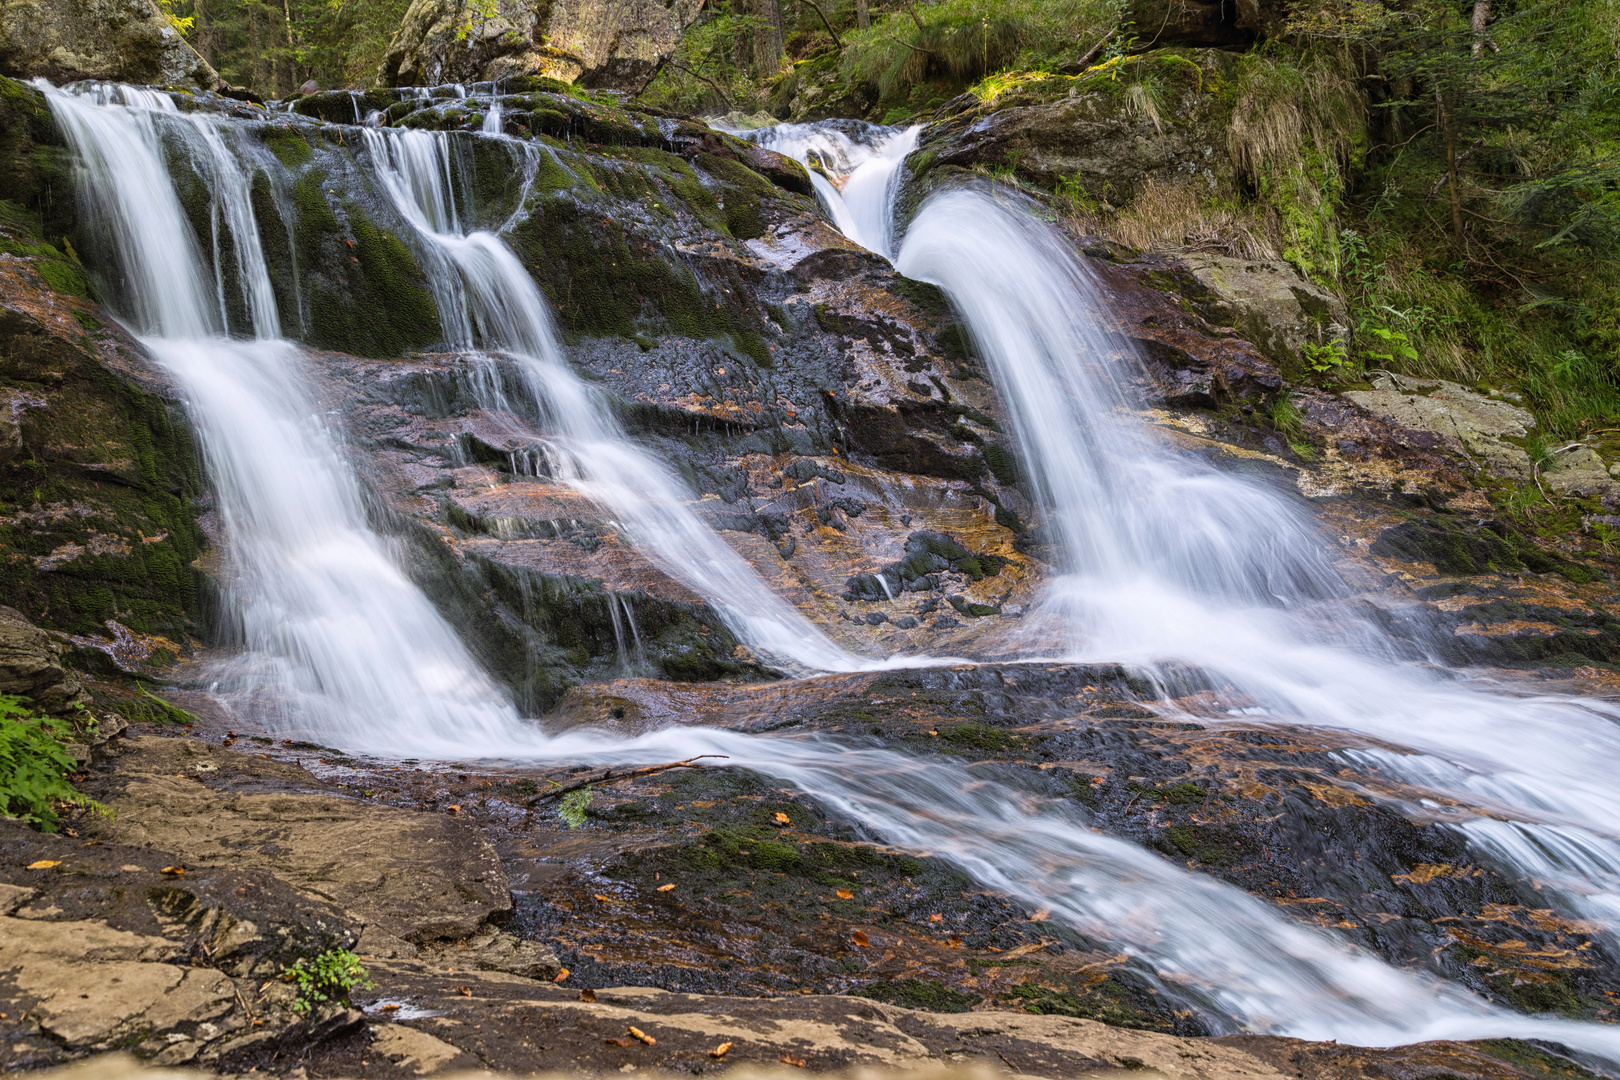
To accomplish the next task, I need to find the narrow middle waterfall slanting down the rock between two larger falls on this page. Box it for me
[365,122,917,672]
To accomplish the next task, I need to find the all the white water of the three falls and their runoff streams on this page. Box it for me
[34,82,1620,1062]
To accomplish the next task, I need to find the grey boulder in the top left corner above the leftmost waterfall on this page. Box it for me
[0,0,220,89]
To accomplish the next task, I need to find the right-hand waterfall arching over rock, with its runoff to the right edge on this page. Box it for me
[757,120,1620,1049]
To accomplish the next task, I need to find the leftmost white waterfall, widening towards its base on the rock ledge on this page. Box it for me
[42,86,517,753]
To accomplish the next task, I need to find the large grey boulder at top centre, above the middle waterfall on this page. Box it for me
[377,0,703,94]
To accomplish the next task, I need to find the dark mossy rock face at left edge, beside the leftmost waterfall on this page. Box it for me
[0,79,204,650]
